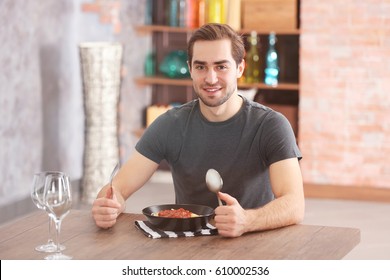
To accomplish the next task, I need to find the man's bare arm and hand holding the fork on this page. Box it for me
[92,152,158,228]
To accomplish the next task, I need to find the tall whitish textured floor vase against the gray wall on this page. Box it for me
[79,42,123,204]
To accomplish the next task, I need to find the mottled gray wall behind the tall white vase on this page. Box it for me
[0,0,151,208]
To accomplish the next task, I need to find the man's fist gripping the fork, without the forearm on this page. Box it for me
[92,187,122,229]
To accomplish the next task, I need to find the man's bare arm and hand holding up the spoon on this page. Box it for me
[215,158,305,237]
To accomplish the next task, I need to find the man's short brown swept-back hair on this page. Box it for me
[187,23,245,67]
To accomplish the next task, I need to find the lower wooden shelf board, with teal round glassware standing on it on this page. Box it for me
[135,76,299,90]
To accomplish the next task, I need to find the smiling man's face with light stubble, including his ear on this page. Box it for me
[190,39,244,107]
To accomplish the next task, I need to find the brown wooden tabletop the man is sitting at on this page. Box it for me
[0,210,360,260]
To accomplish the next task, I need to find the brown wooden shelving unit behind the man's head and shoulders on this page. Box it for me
[135,1,301,138]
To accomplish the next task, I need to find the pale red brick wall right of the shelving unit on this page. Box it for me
[299,0,390,188]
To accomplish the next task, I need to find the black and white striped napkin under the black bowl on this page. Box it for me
[134,221,218,238]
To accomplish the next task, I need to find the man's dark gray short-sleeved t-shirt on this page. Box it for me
[136,98,301,209]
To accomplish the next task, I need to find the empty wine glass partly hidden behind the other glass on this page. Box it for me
[31,171,65,253]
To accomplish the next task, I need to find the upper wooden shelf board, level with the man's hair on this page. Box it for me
[135,25,301,35]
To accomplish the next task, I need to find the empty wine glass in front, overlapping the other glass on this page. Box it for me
[43,174,72,260]
